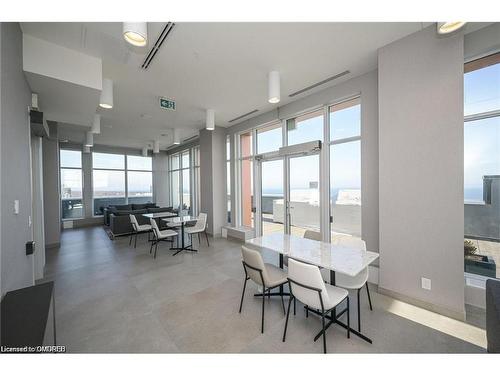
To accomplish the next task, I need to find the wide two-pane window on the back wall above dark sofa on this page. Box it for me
[92,152,153,215]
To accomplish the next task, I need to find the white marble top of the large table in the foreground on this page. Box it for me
[246,233,379,276]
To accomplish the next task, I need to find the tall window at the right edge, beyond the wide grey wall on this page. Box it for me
[464,53,500,277]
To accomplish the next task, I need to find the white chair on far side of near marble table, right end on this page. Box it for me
[334,236,373,332]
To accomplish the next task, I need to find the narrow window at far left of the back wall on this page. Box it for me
[60,150,84,220]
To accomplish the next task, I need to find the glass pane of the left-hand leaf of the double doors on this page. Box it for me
[260,159,286,235]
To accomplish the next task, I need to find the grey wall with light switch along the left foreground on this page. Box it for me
[0,22,34,295]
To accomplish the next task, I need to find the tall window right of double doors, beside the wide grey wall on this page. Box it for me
[329,98,361,242]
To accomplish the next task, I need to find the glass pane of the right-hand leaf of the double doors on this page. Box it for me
[288,154,321,237]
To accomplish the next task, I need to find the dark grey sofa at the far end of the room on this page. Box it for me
[107,203,176,237]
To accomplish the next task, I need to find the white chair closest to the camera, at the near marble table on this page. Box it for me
[283,259,350,353]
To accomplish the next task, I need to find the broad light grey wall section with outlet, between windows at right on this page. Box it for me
[378,26,464,318]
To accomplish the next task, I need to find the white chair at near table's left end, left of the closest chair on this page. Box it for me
[239,246,287,333]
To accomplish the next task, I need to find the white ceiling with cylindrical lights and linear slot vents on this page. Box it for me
[21,23,488,148]
